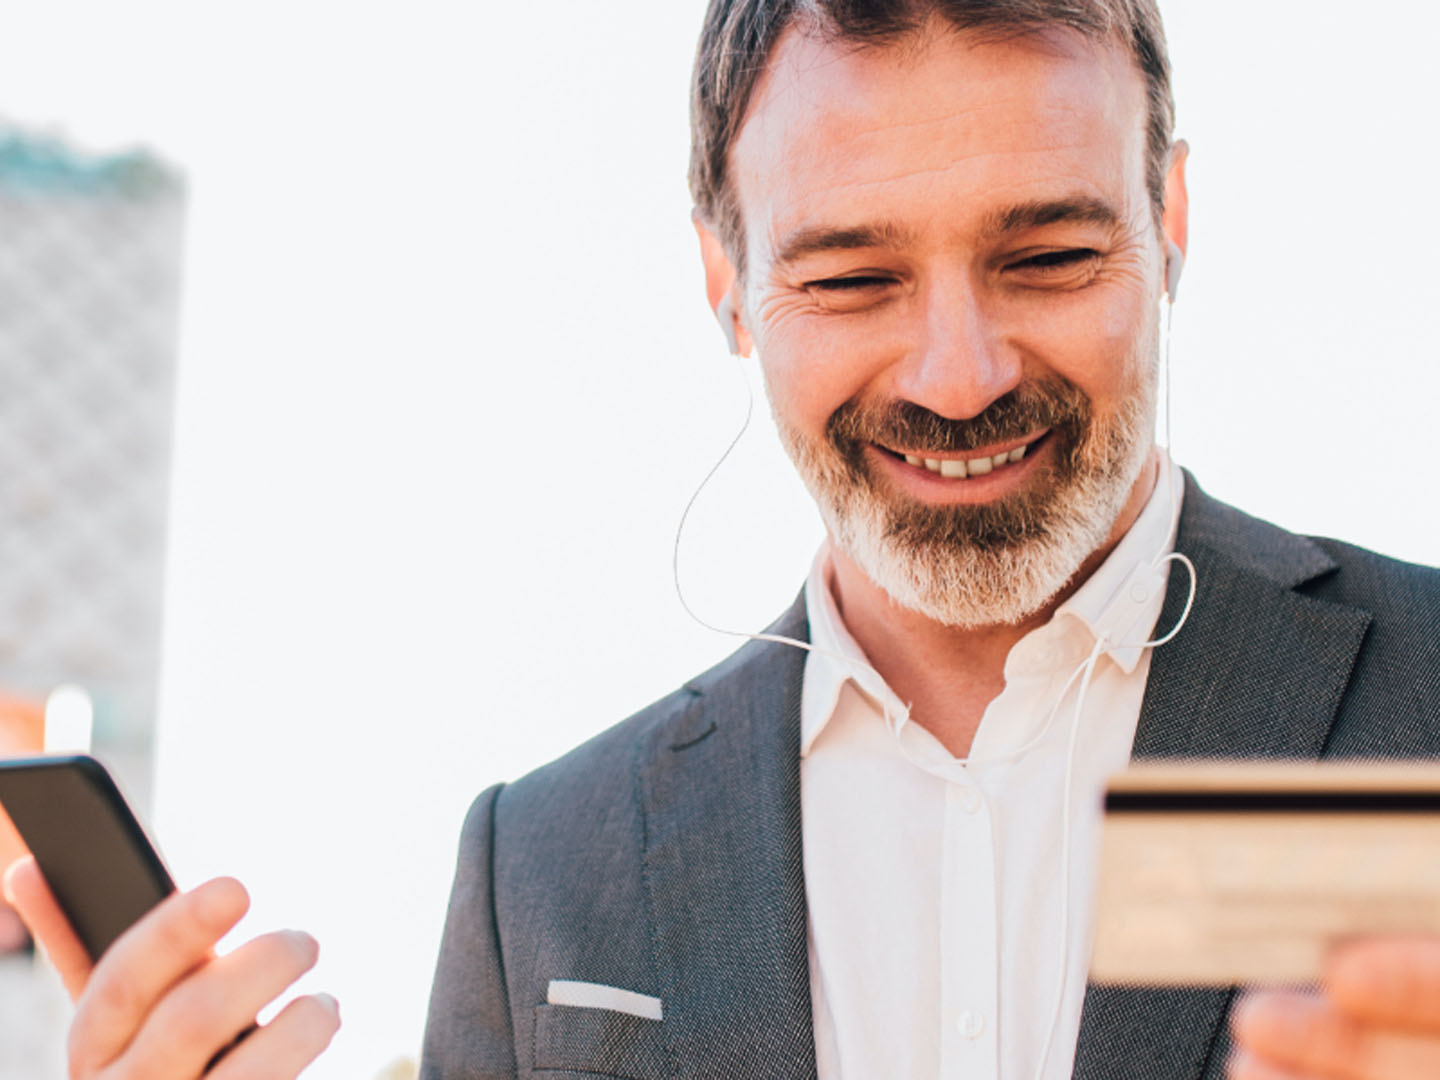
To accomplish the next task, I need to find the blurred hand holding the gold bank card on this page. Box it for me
[1228,937,1440,1080]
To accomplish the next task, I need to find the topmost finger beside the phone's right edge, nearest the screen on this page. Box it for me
[69,877,251,1073]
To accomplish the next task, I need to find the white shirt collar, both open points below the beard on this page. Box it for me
[801,454,1185,757]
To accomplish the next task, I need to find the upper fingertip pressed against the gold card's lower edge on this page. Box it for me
[1325,937,1440,1032]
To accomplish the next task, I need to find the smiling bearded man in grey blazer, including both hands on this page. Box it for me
[2,0,1440,1080]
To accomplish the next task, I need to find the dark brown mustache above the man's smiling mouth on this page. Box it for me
[825,379,1092,461]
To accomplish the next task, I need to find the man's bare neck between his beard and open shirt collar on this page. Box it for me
[829,454,1159,757]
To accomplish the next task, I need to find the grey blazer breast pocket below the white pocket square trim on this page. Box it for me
[534,1005,668,1080]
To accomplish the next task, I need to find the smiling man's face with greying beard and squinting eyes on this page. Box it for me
[732,21,1164,626]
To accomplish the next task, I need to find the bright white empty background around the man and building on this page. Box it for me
[0,0,1440,1080]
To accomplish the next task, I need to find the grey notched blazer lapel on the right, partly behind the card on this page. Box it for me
[1074,478,1369,1080]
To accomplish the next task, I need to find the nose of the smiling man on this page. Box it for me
[894,269,1021,420]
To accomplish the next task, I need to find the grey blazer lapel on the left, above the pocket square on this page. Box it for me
[636,600,815,1080]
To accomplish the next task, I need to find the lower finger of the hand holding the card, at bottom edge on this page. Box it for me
[1231,994,1440,1080]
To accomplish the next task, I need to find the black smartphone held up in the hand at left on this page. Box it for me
[0,755,176,960]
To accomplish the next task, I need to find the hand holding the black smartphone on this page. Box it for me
[4,857,340,1080]
